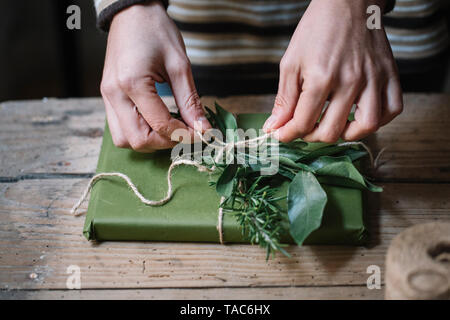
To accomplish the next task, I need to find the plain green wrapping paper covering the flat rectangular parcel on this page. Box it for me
[83,114,367,245]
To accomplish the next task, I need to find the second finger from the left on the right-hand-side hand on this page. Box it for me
[278,77,330,142]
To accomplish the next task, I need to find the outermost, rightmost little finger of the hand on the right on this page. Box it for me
[380,76,403,126]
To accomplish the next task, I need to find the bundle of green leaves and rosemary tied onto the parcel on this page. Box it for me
[202,103,382,258]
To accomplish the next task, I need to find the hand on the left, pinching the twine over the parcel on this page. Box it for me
[101,1,211,152]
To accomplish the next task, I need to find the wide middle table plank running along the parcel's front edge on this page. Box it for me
[0,179,450,289]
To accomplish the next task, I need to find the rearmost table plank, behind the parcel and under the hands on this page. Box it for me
[0,94,450,182]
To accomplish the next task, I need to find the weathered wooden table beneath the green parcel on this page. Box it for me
[0,95,450,299]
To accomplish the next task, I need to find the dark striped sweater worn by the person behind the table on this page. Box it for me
[94,0,449,95]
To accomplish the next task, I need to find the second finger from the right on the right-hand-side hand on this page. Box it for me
[342,81,381,141]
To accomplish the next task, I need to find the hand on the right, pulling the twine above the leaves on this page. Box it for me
[264,0,403,143]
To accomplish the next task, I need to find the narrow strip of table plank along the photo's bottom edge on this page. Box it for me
[0,286,384,300]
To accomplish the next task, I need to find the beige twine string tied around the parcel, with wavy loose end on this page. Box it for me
[70,132,384,244]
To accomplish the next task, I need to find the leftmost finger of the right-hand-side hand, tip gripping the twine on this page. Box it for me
[263,60,301,132]
